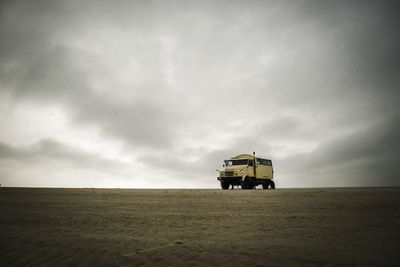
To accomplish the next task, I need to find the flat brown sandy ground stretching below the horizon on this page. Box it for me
[0,188,400,266]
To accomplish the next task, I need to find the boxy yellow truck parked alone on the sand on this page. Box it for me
[217,153,275,190]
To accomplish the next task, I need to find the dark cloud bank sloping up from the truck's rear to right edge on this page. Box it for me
[277,116,400,186]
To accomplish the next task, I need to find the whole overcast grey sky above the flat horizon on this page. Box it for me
[0,0,400,188]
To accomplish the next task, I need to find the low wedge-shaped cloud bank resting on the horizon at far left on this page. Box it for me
[0,139,136,187]
